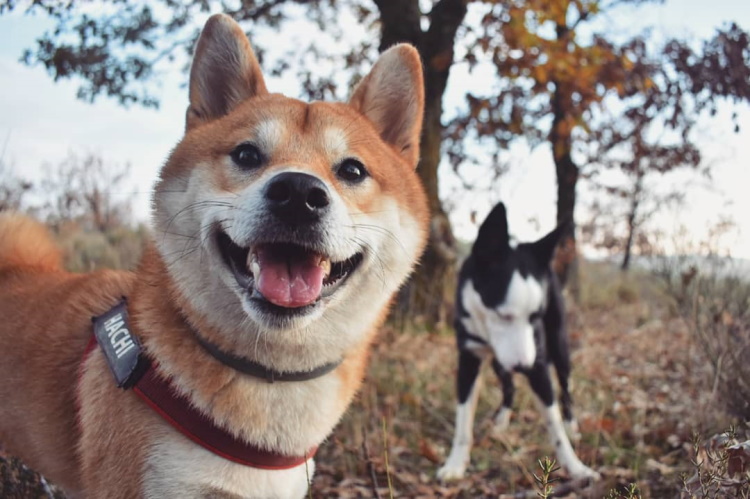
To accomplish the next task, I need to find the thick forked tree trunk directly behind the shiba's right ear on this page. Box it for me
[375,0,466,327]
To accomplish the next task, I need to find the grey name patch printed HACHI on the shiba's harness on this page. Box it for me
[92,301,147,388]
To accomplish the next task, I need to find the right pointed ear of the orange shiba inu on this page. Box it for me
[349,43,424,168]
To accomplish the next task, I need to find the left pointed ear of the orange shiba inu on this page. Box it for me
[186,14,268,130]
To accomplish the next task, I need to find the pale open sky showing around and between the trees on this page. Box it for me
[0,0,750,259]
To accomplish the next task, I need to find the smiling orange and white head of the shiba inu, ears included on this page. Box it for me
[154,15,427,369]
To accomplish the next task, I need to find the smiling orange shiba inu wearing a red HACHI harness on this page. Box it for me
[0,15,428,498]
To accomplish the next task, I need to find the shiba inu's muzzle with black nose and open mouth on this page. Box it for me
[216,172,364,315]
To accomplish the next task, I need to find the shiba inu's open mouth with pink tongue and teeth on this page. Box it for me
[216,228,364,311]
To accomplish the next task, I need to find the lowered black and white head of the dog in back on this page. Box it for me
[459,203,566,369]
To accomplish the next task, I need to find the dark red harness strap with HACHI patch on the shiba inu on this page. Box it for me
[83,300,318,470]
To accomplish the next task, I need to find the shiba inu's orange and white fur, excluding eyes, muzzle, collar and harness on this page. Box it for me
[0,12,428,498]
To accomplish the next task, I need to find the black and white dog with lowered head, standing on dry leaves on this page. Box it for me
[437,203,599,480]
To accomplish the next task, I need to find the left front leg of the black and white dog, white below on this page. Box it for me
[437,350,482,480]
